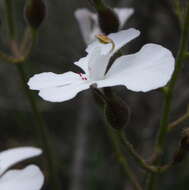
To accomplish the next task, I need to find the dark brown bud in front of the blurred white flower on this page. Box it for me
[90,0,120,35]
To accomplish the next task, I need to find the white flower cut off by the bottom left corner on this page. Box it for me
[0,147,44,190]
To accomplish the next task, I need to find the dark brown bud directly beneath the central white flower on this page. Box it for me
[105,88,130,129]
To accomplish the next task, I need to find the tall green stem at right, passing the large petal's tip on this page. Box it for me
[147,3,189,190]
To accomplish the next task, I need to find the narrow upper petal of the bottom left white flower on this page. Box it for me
[0,147,42,176]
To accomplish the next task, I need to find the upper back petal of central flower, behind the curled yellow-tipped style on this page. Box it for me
[86,28,140,55]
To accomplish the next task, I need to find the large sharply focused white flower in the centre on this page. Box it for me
[28,29,175,102]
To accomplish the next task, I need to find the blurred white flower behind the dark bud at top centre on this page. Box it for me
[75,8,134,44]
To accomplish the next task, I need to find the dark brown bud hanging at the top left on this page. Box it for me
[24,0,46,29]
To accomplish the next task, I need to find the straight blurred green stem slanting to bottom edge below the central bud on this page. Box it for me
[107,127,142,190]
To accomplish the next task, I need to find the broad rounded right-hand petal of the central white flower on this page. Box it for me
[98,44,175,92]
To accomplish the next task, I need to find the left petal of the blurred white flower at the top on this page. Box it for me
[75,8,99,44]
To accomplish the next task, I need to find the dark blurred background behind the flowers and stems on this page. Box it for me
[0,0,189,190]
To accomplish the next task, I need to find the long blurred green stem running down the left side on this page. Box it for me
[5,0,60,190]
